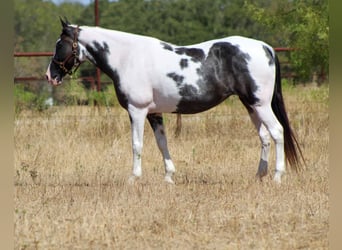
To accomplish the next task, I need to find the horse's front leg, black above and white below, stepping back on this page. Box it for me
[147,113,175,184]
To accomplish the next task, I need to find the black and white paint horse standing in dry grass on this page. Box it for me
[46,19,304,183]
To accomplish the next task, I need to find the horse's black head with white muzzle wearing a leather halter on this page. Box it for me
[46,19,84,86]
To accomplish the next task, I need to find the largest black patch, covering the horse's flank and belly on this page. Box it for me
[172,42,258,114]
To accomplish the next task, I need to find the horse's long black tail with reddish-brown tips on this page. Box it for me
[271,54,305,171]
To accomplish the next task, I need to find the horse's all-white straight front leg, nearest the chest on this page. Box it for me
[128,106,147,184]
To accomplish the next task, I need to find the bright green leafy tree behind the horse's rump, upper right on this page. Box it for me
[245,0,329,81]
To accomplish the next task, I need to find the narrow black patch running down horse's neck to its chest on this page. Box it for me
[86,41,128,109]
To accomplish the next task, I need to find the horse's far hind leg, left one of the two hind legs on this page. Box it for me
[249,110,271,179]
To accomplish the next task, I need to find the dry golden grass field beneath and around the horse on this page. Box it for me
[14,83,329,249]
